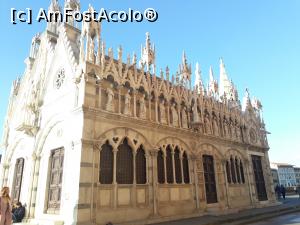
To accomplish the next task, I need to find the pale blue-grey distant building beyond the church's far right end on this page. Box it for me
[271,163,297,187]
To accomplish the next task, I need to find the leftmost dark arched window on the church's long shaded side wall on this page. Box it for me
[99,141,114,184]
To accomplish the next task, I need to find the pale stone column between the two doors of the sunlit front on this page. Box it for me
[28,154,41,218]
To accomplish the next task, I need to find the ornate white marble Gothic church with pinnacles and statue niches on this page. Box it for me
[0,0,276,225]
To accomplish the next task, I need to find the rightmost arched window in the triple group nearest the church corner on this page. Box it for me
[135,146,147,184]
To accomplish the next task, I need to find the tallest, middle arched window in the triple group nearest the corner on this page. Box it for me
[116,138,133,184]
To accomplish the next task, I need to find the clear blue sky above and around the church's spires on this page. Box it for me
[0,0,300,166]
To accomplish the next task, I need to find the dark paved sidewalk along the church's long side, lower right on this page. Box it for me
[152,195,300,225]
